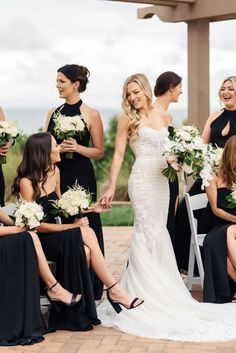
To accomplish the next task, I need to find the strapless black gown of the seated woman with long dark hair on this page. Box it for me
[37,192,100,331]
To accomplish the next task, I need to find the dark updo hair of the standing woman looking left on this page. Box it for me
[57,64,90,92]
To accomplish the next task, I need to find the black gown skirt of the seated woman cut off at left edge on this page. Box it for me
[0,232,45,346]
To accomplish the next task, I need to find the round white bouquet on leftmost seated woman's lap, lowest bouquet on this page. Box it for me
[14,200,44,230]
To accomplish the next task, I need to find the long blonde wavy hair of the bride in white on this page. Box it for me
[122,73,152,141]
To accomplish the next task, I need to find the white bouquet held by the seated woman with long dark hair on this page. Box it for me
[52,183,92,218]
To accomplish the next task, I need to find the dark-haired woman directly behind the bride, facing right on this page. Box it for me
[153,71,182,248]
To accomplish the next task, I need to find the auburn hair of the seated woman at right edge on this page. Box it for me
[220,136,236,189]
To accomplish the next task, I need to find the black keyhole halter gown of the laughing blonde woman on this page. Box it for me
[175,109,236,271]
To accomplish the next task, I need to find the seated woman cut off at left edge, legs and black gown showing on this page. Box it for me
[0,210,81,346]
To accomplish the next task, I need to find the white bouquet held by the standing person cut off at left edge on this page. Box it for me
[0,120,19,164]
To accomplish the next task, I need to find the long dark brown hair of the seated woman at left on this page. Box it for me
[12,132,54,200]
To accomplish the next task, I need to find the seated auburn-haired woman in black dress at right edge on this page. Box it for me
[203,136,236,303]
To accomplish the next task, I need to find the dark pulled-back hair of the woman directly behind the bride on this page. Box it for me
[154,71,182,97]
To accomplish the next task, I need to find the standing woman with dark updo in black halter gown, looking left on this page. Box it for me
[45,64,104,299]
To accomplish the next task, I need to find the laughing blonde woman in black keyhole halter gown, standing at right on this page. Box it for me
[176,76,236,271]
